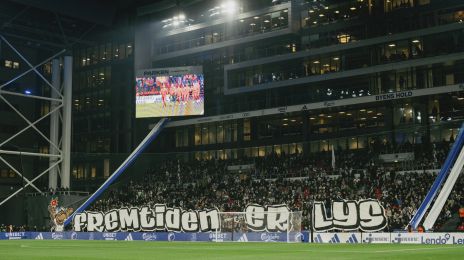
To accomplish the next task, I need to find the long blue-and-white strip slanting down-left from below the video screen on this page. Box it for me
[64,118,169,226]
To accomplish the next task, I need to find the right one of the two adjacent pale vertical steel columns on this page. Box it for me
[61,56,72,188]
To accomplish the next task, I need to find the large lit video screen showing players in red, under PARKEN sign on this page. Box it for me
[135,67,205,118]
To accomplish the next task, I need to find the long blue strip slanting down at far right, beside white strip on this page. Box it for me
[409,123,464,229]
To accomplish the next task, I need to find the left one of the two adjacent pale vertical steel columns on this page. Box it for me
[48,59,61,189]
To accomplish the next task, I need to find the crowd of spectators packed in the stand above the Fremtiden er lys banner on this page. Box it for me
[92,146,464,231]
